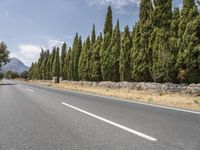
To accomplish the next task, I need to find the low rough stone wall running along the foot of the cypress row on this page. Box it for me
[62,81,200,96]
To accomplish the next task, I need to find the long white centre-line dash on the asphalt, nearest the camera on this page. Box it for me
[62,103,157,142]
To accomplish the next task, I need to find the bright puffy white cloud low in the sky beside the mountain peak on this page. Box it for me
[10,44,41,66]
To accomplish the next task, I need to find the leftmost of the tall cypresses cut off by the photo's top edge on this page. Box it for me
[132,0,153,81]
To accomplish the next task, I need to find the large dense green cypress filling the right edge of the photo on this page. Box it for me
[176,0,199,83]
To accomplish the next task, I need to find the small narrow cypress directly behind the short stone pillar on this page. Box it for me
[53,47,60,79]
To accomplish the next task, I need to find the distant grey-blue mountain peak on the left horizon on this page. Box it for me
[1,58,29,73]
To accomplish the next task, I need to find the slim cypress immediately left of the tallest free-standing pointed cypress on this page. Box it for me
[91,33,102,81]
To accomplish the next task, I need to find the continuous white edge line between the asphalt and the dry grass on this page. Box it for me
[61,90,200,115]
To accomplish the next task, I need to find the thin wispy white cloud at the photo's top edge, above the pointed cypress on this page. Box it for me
[86,0,140,9]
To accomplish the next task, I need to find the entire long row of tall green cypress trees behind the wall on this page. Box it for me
[29,0,200,83]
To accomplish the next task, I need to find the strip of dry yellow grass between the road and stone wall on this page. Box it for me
[29,81,200,110]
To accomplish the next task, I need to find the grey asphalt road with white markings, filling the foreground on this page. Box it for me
[0,80,200,150]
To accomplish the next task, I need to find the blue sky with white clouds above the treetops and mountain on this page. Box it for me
[0,0,182,66]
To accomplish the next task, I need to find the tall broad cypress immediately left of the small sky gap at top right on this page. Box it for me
[150,0,173,82]
